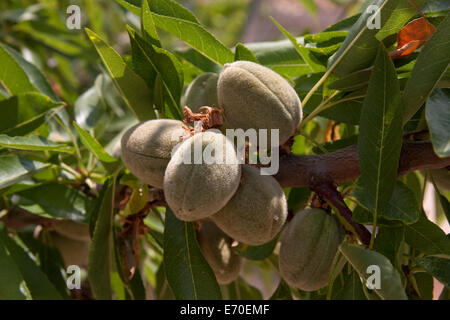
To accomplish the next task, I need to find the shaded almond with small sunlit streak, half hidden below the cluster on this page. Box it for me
[197,221,242,284]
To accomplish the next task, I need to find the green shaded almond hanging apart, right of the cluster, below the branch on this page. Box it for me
[278,209,344,291]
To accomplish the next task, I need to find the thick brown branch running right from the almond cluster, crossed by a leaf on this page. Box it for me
[275,141,450,188]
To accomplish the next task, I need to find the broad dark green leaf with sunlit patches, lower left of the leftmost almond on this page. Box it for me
[16,182,94,223]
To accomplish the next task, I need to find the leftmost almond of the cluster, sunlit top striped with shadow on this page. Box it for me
[121,119,187,188]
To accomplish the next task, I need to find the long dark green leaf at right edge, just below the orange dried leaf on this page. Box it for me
[402,14,450,123]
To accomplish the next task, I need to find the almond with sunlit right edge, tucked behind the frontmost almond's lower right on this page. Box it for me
[211,165,287,245]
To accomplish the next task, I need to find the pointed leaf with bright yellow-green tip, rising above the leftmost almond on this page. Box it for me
[86,29,156,121]
